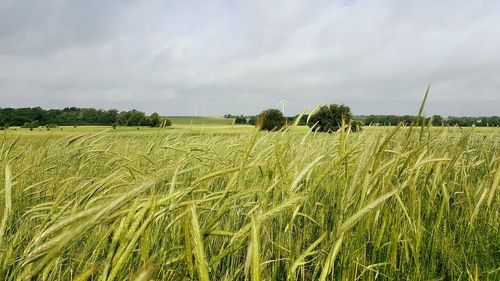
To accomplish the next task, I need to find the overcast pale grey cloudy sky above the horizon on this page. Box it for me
[0,0,500,116]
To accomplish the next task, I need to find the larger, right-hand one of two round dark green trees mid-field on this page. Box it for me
[309,103,356,132]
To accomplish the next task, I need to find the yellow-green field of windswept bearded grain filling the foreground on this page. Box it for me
[0,123,500,281]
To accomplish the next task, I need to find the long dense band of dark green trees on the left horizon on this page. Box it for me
[0,107,172,127]
